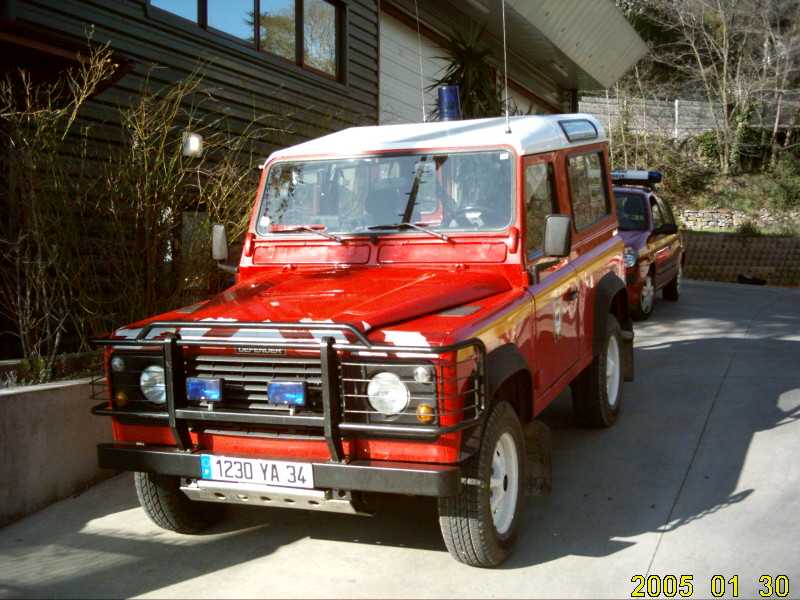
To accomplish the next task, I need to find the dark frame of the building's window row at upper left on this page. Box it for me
[145,0,348,84]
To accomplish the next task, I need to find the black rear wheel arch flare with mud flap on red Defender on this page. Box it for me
[592,273,633,381]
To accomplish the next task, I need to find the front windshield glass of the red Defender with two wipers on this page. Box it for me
[256,150,514,235]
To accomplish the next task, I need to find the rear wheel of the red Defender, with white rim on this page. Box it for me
[572,315,622,427]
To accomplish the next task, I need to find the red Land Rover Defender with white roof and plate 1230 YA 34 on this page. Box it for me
[93,115,633,566]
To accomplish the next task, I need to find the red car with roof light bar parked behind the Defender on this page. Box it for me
[611,170,686,320]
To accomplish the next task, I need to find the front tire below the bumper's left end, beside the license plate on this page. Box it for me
[133,473,228,533]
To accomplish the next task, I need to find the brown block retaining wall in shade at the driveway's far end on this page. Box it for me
[683,231,800,286]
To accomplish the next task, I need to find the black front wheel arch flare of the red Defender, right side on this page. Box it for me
[459,344,533,460]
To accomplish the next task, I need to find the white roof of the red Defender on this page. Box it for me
[269,114,607,161]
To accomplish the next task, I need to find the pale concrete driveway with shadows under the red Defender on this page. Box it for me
[0,282,800,598]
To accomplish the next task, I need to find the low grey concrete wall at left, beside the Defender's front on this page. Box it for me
[0,380,115,527]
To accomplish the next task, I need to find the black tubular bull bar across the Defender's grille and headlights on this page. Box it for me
[92,321,487,462]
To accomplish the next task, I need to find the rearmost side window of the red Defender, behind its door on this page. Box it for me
[567,152,611,231]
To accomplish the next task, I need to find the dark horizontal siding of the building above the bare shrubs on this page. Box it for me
[14,0,378,154]
